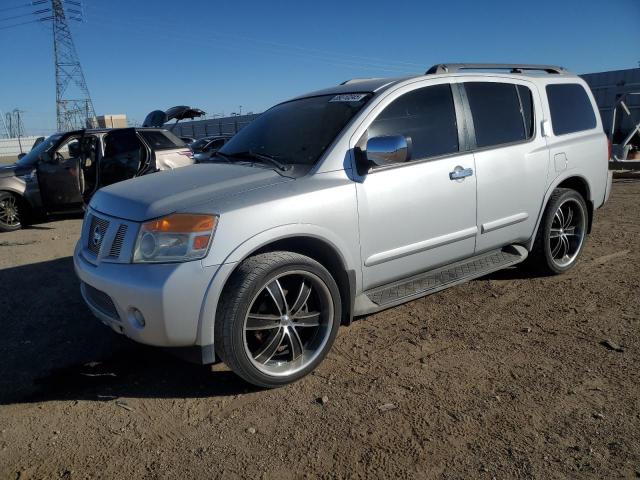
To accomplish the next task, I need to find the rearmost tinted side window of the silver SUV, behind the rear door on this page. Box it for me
[547,83,596,135]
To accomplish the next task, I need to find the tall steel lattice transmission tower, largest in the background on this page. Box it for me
[32,0,96,132]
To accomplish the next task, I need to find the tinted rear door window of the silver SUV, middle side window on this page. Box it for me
[464,82,527,147]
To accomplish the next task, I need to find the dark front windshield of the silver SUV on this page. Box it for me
[219,93,371,165]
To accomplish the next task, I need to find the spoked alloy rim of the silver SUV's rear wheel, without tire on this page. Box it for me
[549,198,587,268]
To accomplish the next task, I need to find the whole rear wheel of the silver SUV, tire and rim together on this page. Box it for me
[527,188,589,275]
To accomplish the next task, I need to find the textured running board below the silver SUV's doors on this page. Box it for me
[355,245,528,315]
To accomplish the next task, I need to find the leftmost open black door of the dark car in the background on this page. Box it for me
[37,137,83,213]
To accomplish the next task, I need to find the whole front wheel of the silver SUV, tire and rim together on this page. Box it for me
[214,252,342,388]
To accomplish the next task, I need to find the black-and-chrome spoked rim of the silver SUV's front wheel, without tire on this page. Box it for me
[244,270,334,376]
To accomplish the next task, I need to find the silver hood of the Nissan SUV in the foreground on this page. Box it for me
[90,164,292,222]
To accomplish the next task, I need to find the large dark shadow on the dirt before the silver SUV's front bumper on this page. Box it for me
[0,257,254,405]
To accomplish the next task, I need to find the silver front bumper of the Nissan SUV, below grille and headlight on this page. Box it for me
[73,242,219,347]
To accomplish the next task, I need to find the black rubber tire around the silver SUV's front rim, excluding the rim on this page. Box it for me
[216,252,342,388]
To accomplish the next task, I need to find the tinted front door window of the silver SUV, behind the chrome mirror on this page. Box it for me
[367,84,458,160]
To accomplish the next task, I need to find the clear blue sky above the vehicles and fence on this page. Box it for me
[0,0,640,134]
